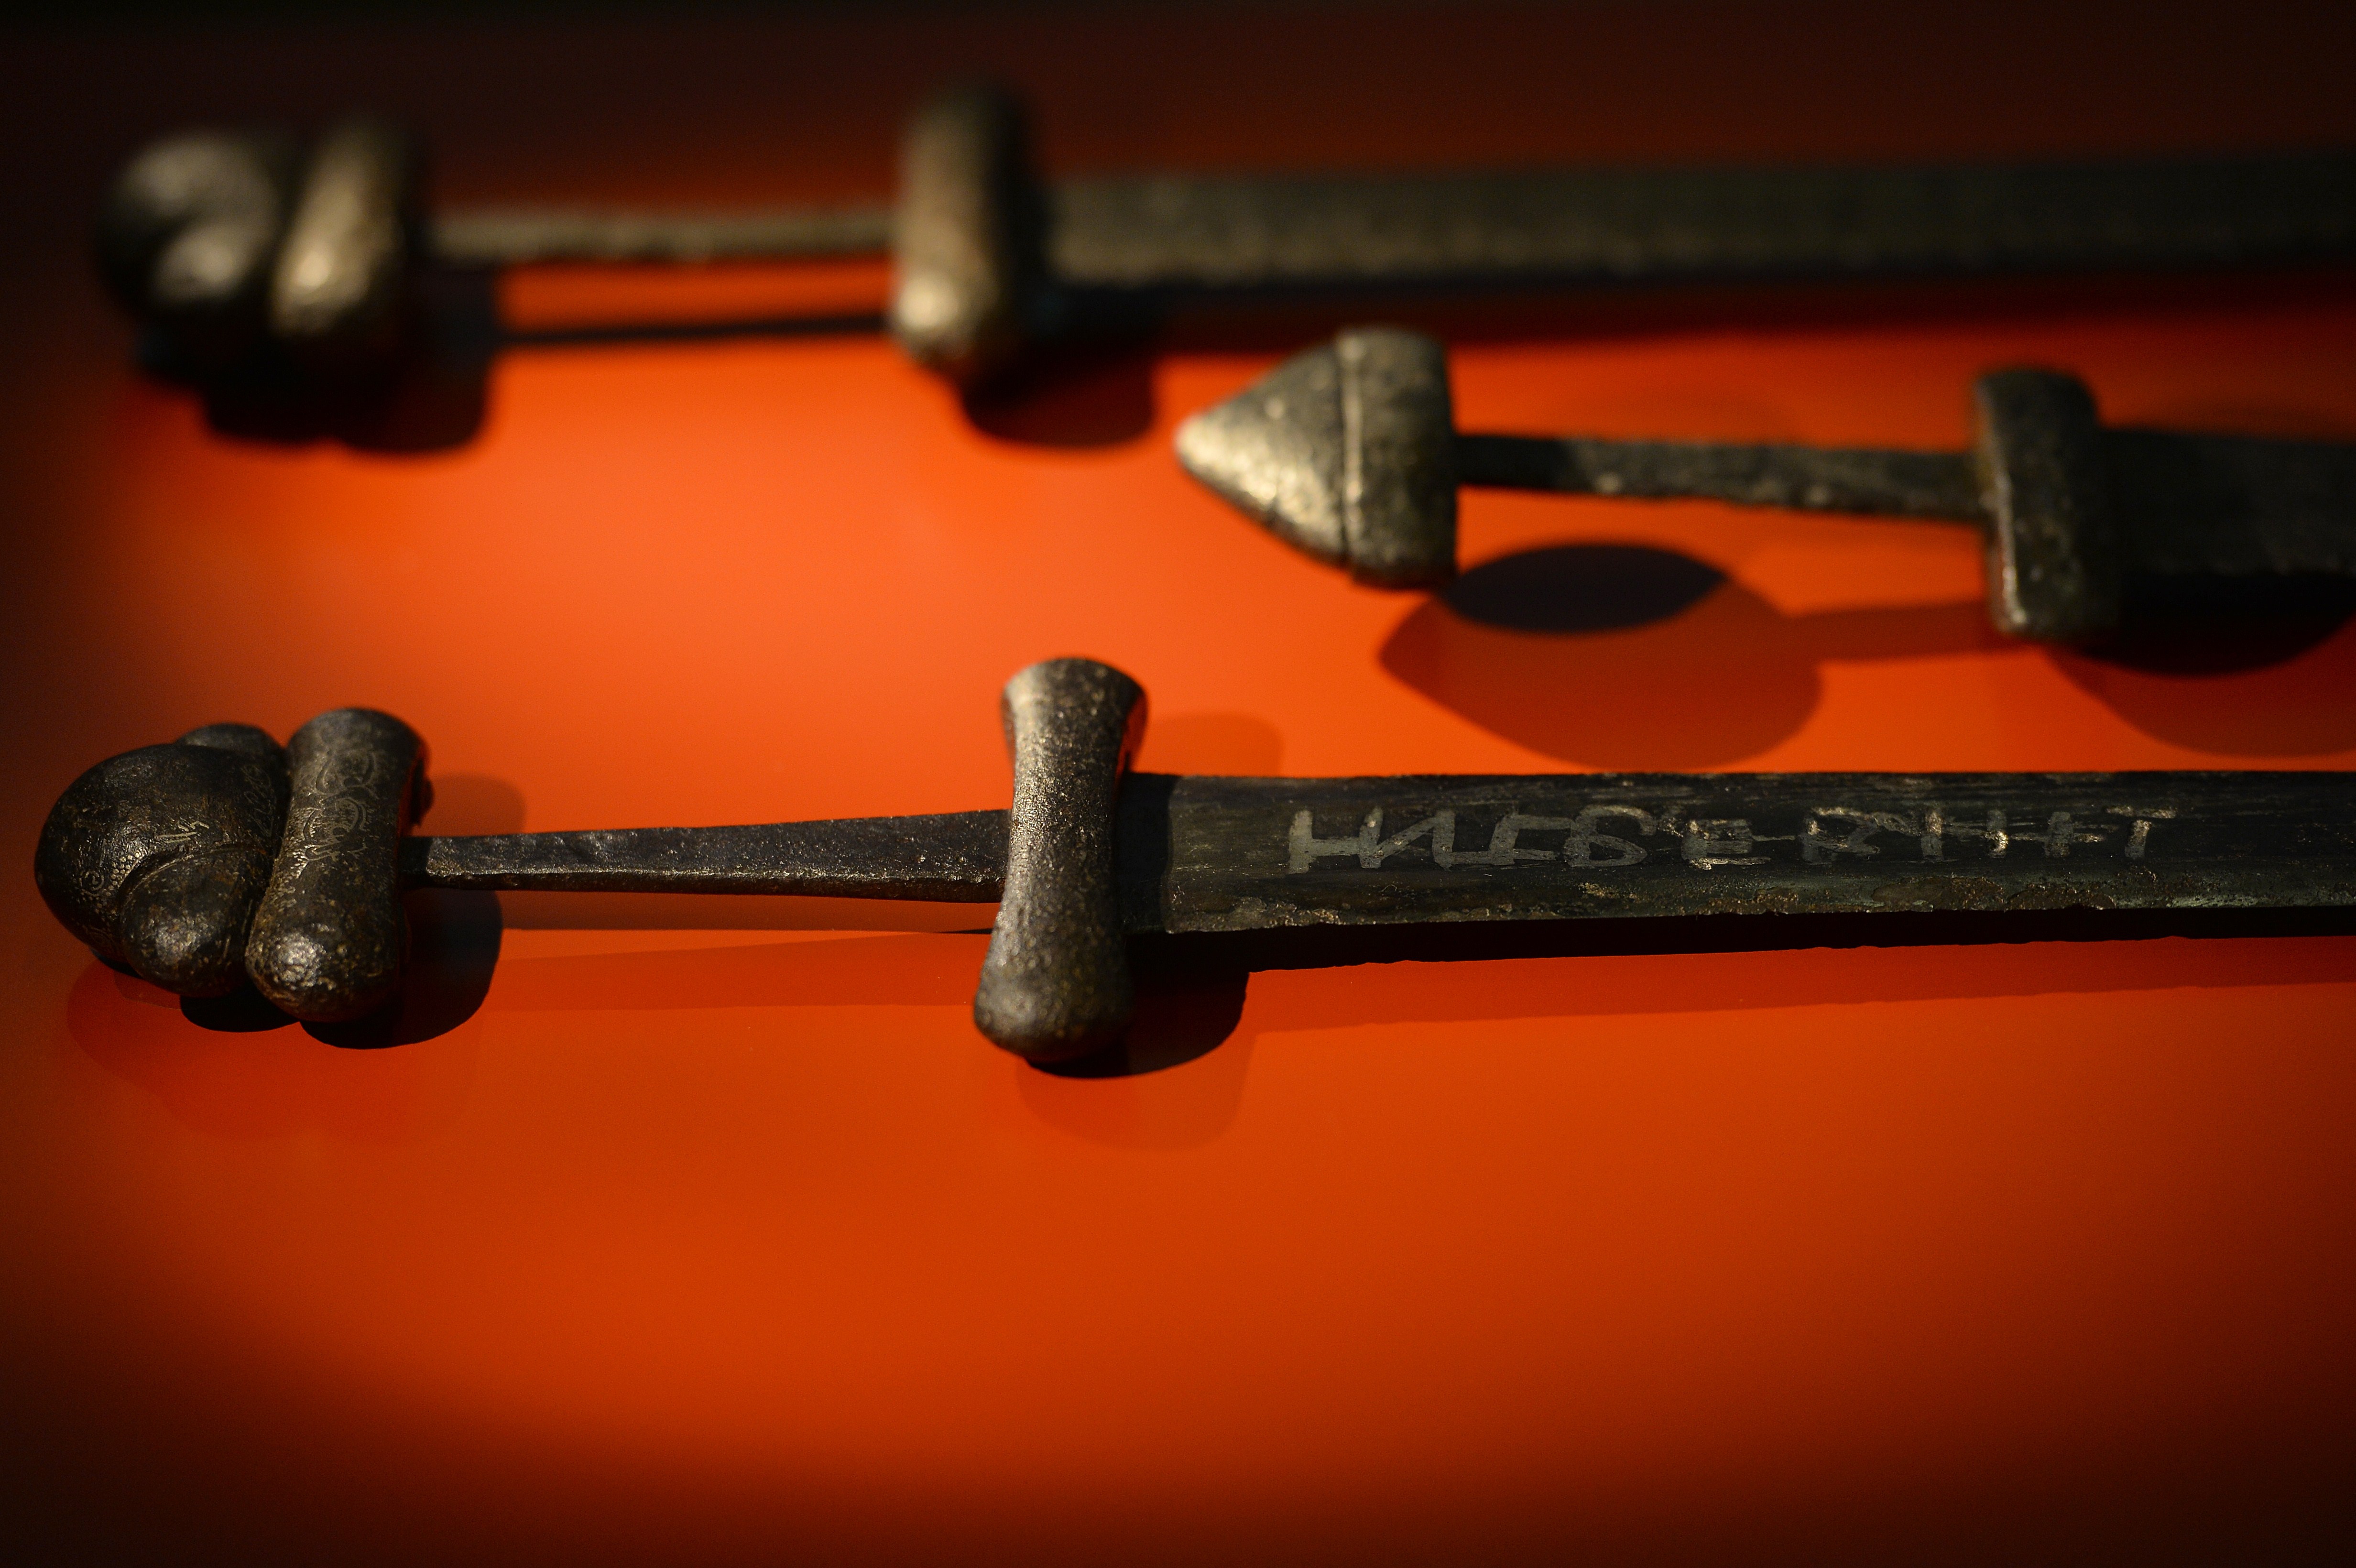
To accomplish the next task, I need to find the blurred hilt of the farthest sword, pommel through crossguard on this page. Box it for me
[97,87,1056,381]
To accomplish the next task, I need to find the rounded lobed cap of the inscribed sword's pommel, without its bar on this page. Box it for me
[33,725,287,996]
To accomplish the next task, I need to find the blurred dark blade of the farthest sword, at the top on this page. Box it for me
[1048,153,2356,287]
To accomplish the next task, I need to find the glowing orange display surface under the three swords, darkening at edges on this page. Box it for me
[0,7,2356,1563]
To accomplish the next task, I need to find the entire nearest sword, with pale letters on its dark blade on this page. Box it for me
[35,659,2356,1059]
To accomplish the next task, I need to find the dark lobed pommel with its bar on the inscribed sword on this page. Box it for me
[33,708,424,1022]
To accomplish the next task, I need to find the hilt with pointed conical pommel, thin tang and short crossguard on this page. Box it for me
[1178,327,2243,643]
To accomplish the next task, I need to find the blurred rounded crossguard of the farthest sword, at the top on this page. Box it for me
[891,85,1051,386]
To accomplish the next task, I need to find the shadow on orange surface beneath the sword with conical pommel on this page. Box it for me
[1381,544,2356,772]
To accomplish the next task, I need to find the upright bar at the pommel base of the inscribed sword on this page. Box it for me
[245,708,424,1024]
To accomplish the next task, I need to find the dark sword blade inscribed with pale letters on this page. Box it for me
[1122,772,2356,932]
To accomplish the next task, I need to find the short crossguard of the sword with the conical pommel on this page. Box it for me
[1972,370,2120,643]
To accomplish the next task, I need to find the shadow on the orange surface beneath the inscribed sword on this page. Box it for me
[68,916,2356,1149]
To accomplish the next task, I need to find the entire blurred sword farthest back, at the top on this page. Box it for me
[99,87,2356,384]
